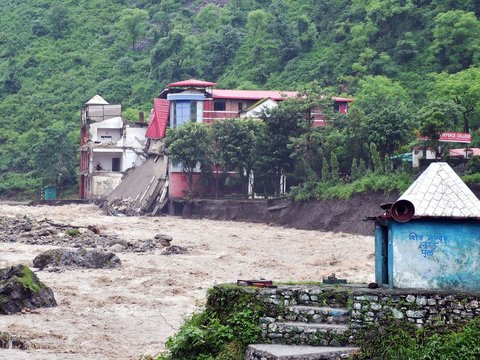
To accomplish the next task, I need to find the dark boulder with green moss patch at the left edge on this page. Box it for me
[0,265,57,315]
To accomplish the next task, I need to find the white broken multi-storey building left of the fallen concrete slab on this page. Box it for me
[80,95,147,199]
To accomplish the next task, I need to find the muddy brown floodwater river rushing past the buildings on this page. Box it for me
[0,205,374,359]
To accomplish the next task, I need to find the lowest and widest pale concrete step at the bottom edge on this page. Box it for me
[244,344,360,360]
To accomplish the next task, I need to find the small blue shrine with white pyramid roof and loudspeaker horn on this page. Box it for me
[375,162,480,291]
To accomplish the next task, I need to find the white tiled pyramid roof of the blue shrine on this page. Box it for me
[399,162,480,218]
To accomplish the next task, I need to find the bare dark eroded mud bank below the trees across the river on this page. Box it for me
[183,192,398,235]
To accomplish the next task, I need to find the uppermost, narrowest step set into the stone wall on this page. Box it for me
[278,305,350,324]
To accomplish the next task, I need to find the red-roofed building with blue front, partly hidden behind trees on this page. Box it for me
[145,79,352,199]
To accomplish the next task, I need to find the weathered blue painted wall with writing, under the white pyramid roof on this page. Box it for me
[388,220,480,291]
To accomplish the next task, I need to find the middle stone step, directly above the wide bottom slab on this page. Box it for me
[260,321,349,346]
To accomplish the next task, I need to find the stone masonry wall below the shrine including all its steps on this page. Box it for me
[234,285,480,360]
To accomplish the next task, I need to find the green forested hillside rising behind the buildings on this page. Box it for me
[0,0,480,195]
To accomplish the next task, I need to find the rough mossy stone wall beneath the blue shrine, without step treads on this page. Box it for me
[225,285,480,345]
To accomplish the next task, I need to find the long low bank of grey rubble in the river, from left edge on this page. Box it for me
[0,216,172,253]
